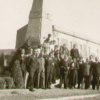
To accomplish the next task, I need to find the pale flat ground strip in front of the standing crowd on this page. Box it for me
[0,88,100,100]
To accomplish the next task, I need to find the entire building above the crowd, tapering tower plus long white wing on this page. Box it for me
[16,0,100,58]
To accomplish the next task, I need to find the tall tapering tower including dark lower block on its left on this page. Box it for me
[16,0,52,48]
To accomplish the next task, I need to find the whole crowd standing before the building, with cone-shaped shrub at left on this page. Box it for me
[11,34,100,91]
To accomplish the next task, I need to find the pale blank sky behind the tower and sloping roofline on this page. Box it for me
[0,0,100,49]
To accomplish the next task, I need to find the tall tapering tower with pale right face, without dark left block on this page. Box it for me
[25,0,52,46]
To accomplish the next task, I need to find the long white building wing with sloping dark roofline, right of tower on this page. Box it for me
[53,26,100,58]
